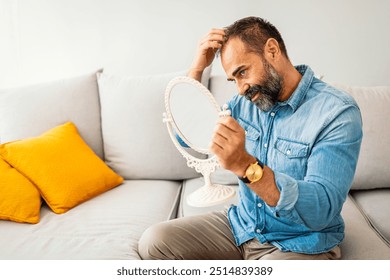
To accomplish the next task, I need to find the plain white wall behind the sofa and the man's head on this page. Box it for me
[0,0,390,88]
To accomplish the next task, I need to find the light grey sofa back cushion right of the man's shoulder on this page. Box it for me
[335,84,390,189]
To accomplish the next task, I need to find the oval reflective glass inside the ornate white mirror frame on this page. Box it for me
[169,81,220,154]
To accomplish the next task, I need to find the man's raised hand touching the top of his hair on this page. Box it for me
[188,29,225,82]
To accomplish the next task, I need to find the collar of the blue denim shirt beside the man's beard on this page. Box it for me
[280,65,314,112]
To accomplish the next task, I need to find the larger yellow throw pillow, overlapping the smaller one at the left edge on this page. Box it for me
[0,122,123,214]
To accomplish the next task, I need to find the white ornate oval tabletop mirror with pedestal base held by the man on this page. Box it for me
[164,76,235,207]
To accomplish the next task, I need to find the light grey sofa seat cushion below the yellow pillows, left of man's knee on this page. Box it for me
[0,180,180,260]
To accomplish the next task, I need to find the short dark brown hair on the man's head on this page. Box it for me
[225,17,288,59]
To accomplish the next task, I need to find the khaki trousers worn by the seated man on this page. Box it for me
[138,211,341,260]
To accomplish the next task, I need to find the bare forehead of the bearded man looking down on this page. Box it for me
[221,37,261,76]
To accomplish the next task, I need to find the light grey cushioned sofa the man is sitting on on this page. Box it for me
[0,70,390,260]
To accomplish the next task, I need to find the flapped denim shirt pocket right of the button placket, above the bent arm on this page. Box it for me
[274,137,309,180]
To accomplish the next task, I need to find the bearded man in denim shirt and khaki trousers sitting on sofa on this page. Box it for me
[139,17,362,259]
